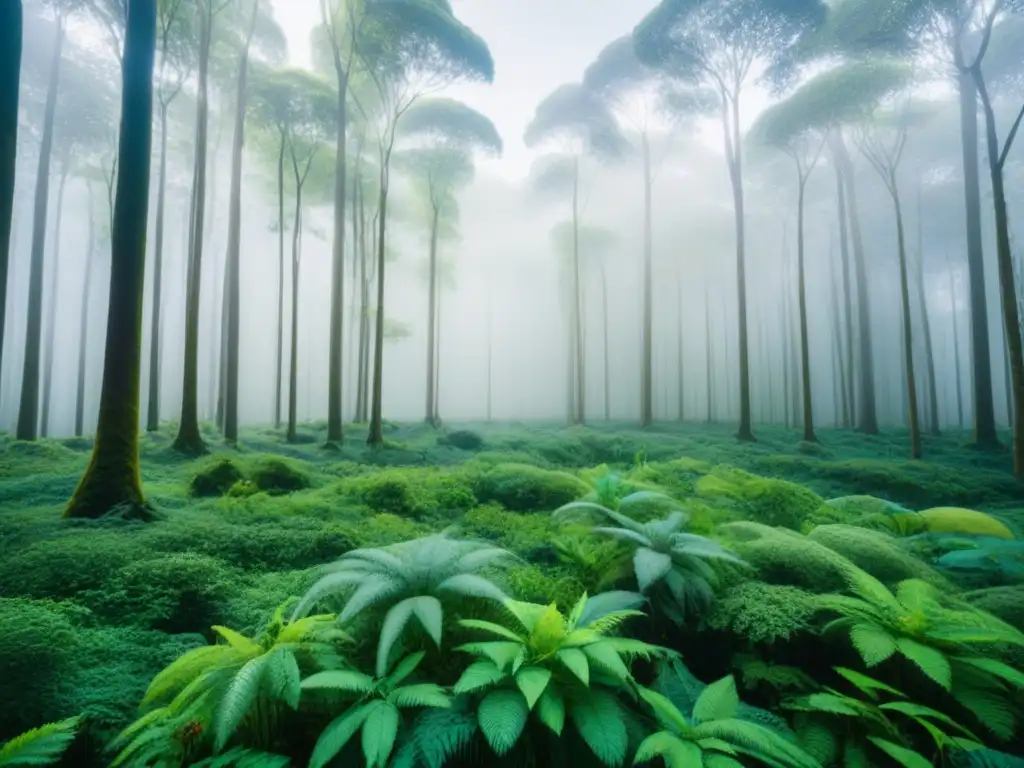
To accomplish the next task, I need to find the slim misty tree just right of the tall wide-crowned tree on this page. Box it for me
[751,89,831,442]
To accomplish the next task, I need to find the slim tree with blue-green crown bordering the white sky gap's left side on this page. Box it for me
[358,0,495,447]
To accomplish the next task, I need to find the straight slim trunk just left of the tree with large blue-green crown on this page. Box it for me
[327,58,352,443]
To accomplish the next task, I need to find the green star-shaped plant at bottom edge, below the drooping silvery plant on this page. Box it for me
[302,651,451,768]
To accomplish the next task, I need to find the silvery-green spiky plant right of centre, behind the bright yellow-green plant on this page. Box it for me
[555,490,745,625]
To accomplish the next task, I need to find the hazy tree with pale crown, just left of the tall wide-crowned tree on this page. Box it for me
[583,35,714,427]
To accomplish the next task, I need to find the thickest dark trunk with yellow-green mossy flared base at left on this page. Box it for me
[65,0,157,519]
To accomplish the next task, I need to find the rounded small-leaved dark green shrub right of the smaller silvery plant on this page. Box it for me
[707,582,818,643]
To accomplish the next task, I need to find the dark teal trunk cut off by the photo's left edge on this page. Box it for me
[0,0,23,385]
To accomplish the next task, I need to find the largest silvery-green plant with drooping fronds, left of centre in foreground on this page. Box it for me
[294,536,510,677]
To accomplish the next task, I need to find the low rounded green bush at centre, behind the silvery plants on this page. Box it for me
[473,464,589,512]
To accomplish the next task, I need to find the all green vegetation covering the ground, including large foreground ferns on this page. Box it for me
[0,425,1024,768]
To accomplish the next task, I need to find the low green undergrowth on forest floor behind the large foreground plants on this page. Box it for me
[0,424,1024,765]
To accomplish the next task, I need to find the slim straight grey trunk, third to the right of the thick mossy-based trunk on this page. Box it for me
[224,0,259,442]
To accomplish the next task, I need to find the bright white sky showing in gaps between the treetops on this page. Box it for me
[272,0,655,178]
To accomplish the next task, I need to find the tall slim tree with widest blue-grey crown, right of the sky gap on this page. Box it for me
[633,0,824,440]
